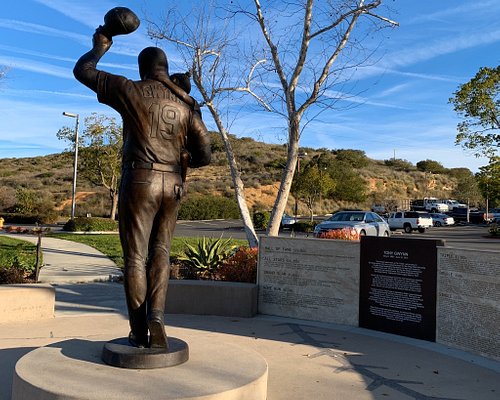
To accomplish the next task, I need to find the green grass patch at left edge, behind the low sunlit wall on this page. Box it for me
[0,236,36,272]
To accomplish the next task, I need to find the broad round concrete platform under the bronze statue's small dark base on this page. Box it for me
[12,337,267,400]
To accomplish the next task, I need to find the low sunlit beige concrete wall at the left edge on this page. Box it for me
[0,284,56,323]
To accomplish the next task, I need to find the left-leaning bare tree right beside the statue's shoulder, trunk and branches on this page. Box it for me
[148,6,266,247]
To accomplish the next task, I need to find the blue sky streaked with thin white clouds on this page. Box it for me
[0,0,500,171]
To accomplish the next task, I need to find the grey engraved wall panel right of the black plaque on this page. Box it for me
[437,248,500,360]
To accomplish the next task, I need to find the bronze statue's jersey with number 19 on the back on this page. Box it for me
[96,71,209,165]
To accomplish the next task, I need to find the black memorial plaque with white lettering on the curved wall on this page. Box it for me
[359,237,442,341]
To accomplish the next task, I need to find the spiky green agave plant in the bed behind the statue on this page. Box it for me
[177,236,238,279]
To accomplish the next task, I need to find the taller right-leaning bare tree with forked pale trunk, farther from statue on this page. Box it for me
[230,0,397,236]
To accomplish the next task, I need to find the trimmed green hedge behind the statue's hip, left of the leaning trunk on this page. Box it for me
[178,195,240,220]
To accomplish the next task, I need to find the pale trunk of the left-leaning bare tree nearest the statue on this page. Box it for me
[207,103,259,247]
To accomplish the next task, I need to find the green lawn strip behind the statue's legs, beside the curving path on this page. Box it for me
[48,233,248,267]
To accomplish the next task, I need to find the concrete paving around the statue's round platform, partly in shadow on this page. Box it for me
[0,234,500,400]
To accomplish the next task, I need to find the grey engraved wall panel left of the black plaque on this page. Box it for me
[258,236,359,326]
